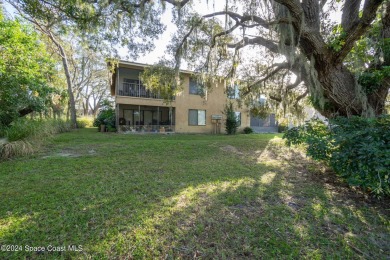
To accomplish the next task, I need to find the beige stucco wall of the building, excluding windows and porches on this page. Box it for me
[115,62,250,133]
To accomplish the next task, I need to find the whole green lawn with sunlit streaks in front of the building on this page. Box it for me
[0,128,390,259]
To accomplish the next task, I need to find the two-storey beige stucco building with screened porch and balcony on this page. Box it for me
[111,61,250,133]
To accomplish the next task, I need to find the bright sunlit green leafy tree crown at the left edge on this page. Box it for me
[0,13,54,126]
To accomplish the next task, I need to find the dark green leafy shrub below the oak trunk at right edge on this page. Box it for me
[283,116,390,196]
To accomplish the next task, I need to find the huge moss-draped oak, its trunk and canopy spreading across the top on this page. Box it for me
[9,0,390,117]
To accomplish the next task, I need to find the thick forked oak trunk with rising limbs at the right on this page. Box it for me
[288,0,390,118]
